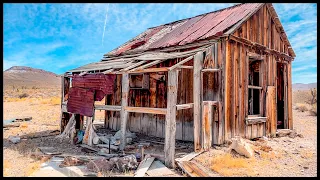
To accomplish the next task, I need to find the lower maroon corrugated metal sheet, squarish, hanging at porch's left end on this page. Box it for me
[67,87,94,117]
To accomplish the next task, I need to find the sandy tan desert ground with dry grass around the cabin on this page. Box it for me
[3,87,317,177]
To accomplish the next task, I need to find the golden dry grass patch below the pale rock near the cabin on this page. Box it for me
[211,154,256,176]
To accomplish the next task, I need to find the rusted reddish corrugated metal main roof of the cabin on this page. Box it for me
[107,3,263,56]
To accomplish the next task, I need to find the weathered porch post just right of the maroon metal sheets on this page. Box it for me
[120,73,129,150]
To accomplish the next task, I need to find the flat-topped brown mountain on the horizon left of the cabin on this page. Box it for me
[3,66,61,88]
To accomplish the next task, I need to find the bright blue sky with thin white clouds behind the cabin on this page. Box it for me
[3,3,317,83]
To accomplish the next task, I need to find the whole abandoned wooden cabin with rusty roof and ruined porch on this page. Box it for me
[61,3,295,166]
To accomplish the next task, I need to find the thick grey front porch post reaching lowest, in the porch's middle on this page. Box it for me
[164,70,178,168]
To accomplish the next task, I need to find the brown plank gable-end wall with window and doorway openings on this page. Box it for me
[225,5,292,139]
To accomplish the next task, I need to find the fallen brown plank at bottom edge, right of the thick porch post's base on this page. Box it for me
[178,161,209,177]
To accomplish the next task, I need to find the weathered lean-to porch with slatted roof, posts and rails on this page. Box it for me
[61,42,223,167]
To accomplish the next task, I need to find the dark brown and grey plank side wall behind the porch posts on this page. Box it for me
[106,56,193,141]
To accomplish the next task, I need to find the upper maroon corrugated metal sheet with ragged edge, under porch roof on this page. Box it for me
[69,73,116,101]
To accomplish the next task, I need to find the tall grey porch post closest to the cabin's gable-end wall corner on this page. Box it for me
[193,52,203,152]
